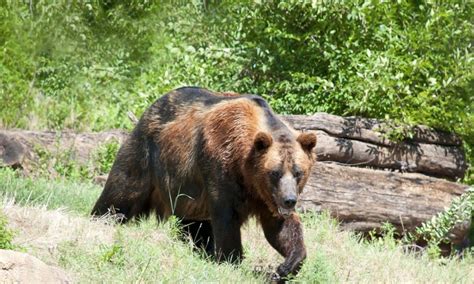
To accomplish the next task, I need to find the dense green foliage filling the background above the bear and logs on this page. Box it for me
[0,0,474,181]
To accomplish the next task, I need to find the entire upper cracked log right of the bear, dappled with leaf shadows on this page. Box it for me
[282,113,467,180]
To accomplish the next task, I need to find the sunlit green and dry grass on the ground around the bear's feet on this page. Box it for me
[0,170,474,283]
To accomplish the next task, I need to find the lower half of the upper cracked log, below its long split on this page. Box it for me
[316,130,467,179]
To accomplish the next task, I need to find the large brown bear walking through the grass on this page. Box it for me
[92,87,316,277]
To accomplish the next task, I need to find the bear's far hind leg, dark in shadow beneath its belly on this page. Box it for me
[181,220,214,256]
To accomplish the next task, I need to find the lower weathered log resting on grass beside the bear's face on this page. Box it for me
[299,162,468,242]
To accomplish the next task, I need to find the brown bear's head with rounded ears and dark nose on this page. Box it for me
[251,131,316,217]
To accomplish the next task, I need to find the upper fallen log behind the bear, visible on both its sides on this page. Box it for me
[0,113,467,180]
